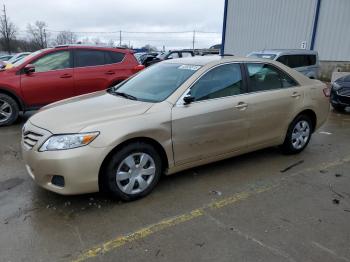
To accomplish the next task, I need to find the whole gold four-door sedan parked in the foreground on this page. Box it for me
[22,56,329,200]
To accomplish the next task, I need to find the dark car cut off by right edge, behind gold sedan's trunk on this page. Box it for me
[331,75,350,111]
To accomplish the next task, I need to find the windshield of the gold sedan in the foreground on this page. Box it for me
[110,63,200,103]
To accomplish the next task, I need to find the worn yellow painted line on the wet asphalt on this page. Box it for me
[73,186,275,262]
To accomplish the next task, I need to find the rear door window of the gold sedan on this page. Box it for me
[247,63,297,92]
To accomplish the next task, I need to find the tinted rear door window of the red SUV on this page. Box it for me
[74,50,105,67]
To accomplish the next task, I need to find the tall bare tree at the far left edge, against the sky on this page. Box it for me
[0,5,16,53]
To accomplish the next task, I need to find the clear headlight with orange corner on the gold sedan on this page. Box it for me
[39,132,100,152]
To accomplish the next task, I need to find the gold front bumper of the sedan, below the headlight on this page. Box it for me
[22,122,106,195]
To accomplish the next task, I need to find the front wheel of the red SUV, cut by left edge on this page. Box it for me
[0,93,19,127]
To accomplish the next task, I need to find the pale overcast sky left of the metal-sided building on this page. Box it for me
[0,0,224,50]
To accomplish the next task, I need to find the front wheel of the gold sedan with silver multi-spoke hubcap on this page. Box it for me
[102,142,162,201]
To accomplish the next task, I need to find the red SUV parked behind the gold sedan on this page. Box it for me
[0,46,144,126]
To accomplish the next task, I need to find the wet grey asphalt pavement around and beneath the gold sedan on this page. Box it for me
[0,108,350,262]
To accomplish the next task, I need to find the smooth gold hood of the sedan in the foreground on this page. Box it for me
[29,91,153,134]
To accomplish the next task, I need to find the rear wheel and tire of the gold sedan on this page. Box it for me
[281,115,314,155]
